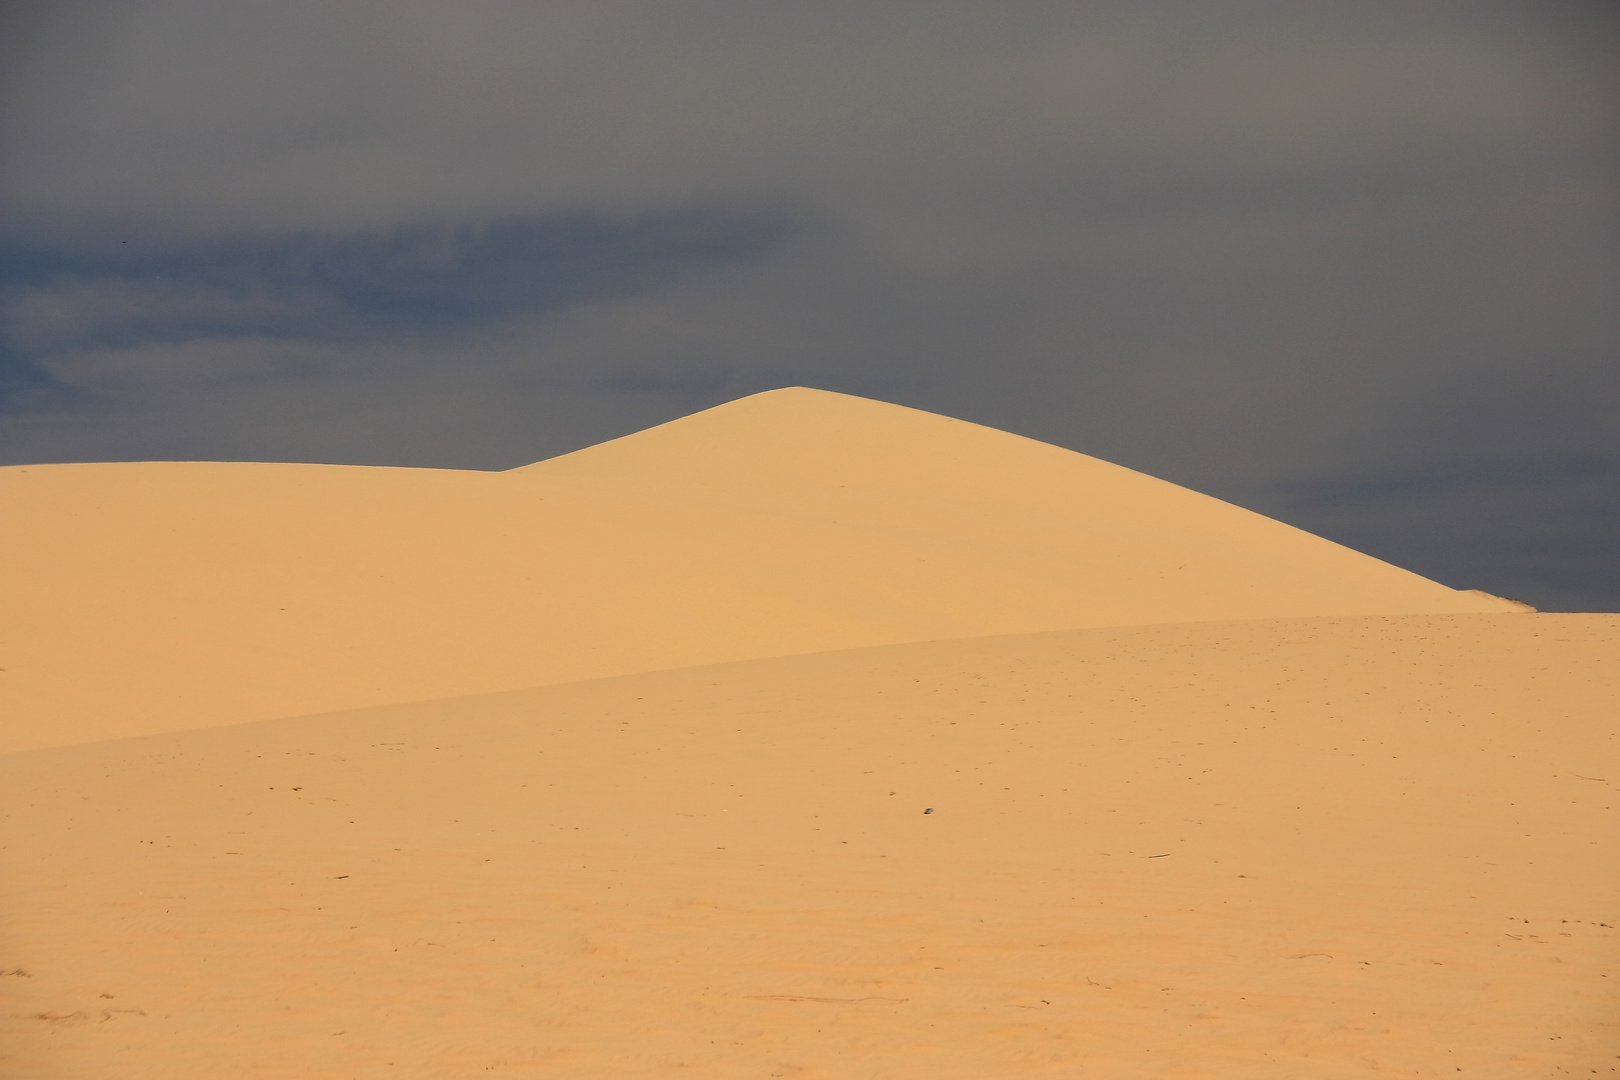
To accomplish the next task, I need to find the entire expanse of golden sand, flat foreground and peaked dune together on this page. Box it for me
[0,392,1620,1080]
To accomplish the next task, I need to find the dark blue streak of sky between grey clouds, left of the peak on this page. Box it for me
[0,209,791,362]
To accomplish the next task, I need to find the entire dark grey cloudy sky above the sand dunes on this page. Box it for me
[0,0,1620,610]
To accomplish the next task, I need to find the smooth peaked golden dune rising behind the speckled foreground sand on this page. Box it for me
[0,389,1510,750]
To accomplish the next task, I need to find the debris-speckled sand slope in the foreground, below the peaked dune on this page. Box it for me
[0,615,1620,1080]
